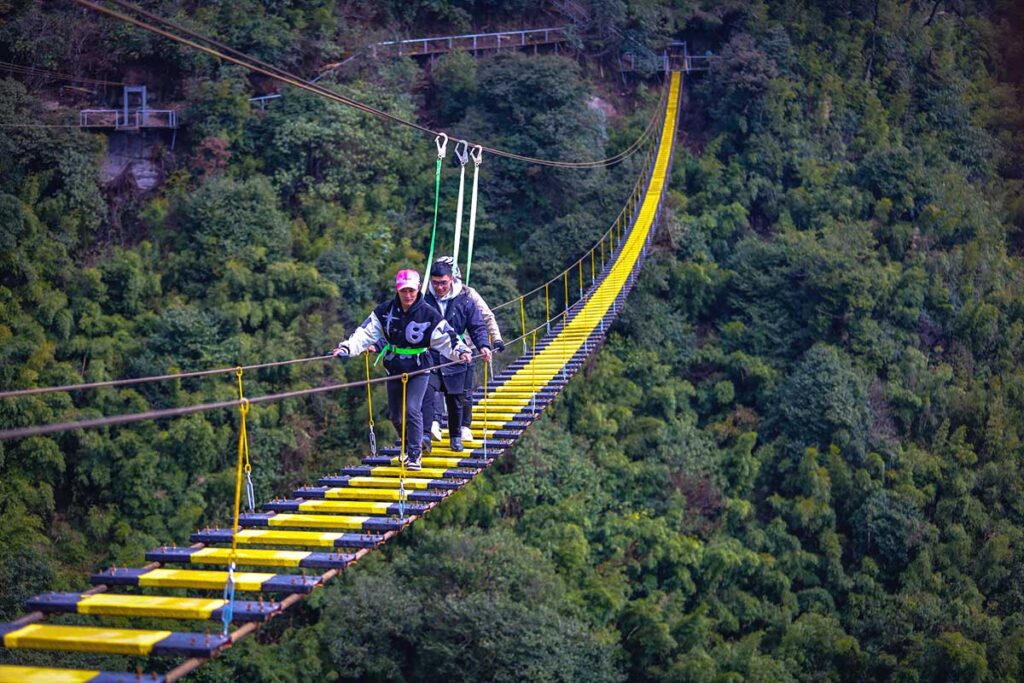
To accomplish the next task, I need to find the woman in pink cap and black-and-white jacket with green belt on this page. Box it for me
[334,268,473,470]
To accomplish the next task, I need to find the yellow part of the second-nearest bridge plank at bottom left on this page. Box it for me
[3,624,171,654]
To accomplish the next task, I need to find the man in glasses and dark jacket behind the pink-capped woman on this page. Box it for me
[423,260,490,452]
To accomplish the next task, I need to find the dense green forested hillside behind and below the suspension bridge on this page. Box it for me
[0,0,1024,681]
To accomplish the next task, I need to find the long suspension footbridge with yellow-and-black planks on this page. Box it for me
[0,2,681,683]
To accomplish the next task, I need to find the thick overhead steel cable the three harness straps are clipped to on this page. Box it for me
[75,0,659,169]
